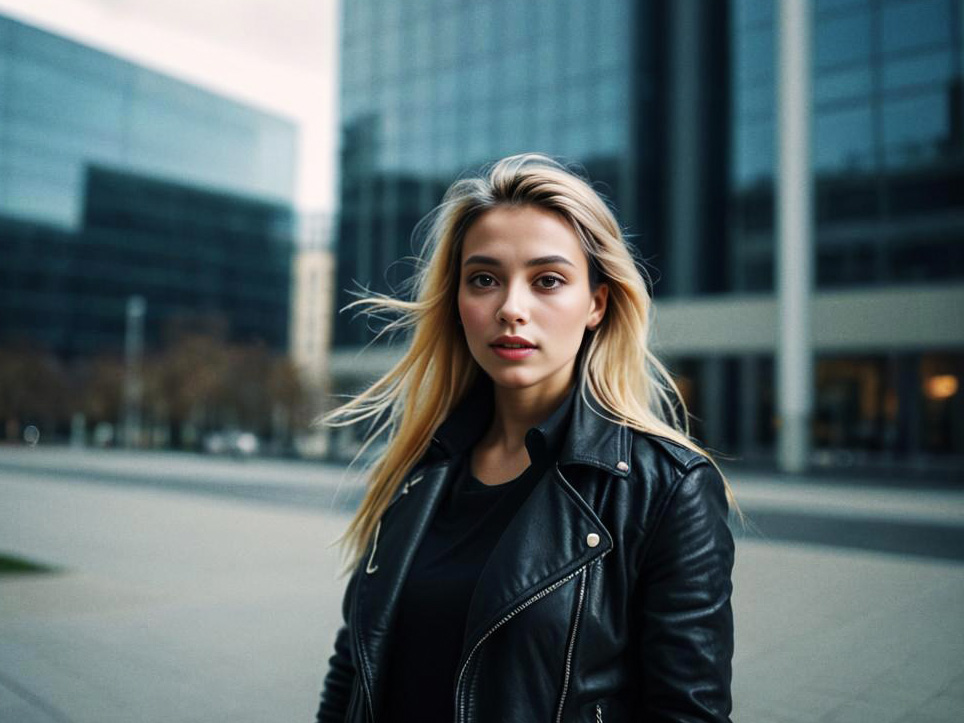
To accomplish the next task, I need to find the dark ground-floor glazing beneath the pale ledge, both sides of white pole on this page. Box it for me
[671,349,964,468]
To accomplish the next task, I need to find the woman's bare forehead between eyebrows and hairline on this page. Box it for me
[462,206,587,265]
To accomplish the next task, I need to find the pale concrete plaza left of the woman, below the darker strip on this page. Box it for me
[0,466,345,723]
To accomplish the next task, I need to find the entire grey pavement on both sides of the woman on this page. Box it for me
[0,448,964,723]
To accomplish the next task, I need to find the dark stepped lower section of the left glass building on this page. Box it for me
[0,167,291,359]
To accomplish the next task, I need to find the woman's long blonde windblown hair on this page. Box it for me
[321,154,738,569]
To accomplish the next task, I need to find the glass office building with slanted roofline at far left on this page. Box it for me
[0,17,296,359]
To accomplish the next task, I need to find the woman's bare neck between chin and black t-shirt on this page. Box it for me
[483,374,575,454]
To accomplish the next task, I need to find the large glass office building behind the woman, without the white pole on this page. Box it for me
[333,0,964,467]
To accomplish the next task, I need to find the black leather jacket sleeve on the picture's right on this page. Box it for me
[635,463,734,723]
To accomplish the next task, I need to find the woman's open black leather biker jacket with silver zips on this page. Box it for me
[318,378,734,723]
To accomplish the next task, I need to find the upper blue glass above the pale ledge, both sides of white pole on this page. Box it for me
[728,0,964,292]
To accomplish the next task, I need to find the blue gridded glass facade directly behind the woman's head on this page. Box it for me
[335,0,639,345]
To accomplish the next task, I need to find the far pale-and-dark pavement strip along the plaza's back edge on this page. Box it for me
[0,447,964,562]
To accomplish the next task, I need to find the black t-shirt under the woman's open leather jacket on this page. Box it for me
[380,384,578,723]
